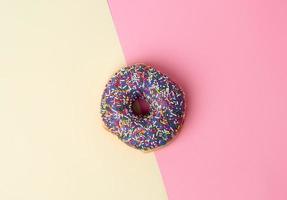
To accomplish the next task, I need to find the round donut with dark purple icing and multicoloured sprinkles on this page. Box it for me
[101,64,185,151]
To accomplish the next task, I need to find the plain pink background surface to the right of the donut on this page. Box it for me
[109,0,287,200]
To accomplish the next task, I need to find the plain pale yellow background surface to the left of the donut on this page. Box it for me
[0,0,167,200]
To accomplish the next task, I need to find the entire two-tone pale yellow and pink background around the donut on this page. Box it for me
[0,0,287,200]
